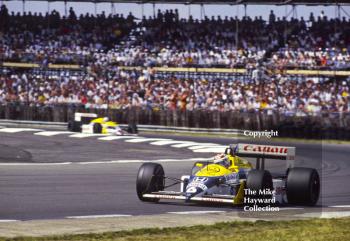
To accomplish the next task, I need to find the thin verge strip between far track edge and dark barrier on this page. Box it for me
[142,131,350,145]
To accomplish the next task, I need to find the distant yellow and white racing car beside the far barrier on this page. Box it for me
[68,113,137,135]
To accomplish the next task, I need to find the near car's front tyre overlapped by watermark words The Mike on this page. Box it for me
[246,170,273,205]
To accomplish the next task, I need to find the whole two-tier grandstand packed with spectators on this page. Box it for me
[0,1,350,137]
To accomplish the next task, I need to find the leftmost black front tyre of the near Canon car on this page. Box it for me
[136,163,164,202]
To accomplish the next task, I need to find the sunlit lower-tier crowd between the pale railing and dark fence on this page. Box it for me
[0,69,350,116]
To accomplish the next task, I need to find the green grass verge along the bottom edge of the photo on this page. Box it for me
[0,218,350,241]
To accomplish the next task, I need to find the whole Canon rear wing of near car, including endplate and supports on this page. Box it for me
[225,143,295,169]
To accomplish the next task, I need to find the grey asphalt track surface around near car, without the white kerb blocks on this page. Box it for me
[0,131,350,220]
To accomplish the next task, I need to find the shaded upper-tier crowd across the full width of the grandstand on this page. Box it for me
[0,5,350,69]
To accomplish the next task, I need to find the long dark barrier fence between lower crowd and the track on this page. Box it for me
[0,103,350,140]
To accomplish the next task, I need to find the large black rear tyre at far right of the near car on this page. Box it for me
[286,167,320,206]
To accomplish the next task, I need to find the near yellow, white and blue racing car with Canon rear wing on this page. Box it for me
[136,143,320,206]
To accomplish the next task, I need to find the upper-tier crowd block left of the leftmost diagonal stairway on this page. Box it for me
[0,5,135,66]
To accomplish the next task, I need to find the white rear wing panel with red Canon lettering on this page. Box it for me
[235,143,295,161]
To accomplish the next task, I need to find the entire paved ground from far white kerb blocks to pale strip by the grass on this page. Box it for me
[0,127,350,236]
